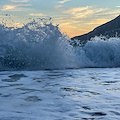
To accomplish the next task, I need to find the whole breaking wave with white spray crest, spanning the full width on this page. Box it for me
[0,20,120,70]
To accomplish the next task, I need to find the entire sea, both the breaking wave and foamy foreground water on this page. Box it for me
[0,19,120,120]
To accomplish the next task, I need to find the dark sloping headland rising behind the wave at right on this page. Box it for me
[71,15,120,44]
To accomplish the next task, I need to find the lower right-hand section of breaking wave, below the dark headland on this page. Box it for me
[75,37,120,67]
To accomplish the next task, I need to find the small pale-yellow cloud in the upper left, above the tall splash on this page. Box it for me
[2,4,31,11]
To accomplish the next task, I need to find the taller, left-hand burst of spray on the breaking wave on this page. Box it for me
[0,20,76,70]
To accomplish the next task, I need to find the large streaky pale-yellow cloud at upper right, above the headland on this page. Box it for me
[55,6,120,20]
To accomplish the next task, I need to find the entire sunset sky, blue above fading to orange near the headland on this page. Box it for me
[0,0,120,37]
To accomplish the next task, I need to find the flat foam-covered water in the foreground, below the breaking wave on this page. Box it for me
[0,68,120,120]
